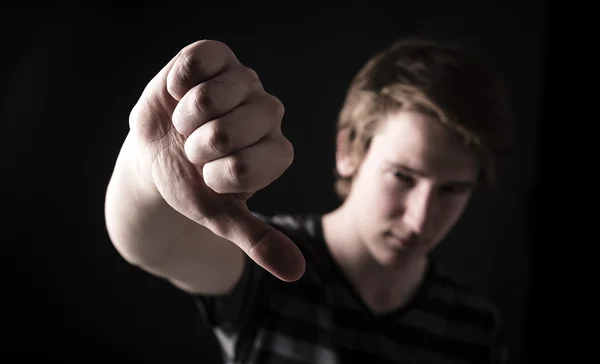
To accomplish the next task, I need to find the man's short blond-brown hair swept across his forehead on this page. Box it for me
[335,37,514,200]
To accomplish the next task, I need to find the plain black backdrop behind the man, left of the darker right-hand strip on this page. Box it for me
[0,0,551,363]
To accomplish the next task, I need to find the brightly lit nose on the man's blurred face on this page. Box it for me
[403,186,434,235]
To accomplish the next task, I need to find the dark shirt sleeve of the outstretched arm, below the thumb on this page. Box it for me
[192,210,271,331]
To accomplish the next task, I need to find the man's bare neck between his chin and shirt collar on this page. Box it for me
[323,207,428,312]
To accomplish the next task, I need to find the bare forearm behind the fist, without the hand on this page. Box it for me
[105,135,244,295]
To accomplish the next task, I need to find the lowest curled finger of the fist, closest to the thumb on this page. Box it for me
[202,135,294,193]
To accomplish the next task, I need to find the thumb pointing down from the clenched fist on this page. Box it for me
[205,204,306,282]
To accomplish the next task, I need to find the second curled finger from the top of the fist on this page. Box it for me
[173,66,262,137]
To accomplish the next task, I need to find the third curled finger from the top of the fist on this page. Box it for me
[184,97,283,166]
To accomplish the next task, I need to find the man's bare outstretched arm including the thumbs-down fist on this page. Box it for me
[105,41,304,294]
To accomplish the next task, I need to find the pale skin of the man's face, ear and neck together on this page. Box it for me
[323,111,478,312]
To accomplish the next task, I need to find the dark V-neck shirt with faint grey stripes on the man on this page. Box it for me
[194,214,507,364]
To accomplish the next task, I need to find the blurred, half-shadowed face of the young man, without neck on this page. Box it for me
[337,111,478,266]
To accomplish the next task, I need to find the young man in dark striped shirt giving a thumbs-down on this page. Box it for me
[105,35,513,364]
